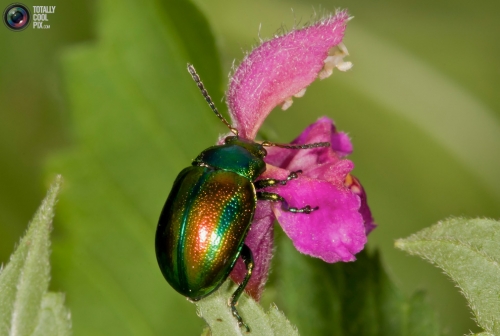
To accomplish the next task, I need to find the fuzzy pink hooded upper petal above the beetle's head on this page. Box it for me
[227,11,349,139]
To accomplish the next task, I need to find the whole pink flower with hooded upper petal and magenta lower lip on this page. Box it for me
[227,11,375,300]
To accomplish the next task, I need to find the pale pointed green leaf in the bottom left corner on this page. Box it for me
[0,175,71,336]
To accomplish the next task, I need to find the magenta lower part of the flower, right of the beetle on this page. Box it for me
[231,117,376,299]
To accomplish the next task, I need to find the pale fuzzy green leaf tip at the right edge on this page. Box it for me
[396,218,500,335]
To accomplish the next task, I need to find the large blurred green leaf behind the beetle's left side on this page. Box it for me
[49,0,224,336]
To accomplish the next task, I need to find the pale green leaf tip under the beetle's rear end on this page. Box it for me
[197,281,299,336]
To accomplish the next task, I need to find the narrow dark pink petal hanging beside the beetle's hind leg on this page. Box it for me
[231,202,274,301]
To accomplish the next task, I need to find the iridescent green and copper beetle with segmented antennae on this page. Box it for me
[155,64,330,331]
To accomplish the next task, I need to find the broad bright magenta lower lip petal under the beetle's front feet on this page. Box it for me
[262,167,366,263]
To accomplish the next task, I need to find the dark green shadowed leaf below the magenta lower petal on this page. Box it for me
[272,228,439,336]
